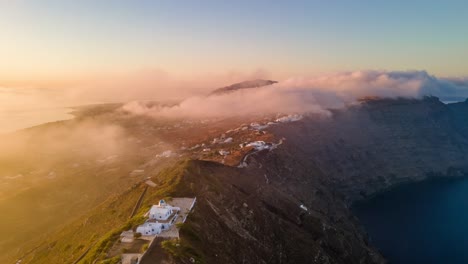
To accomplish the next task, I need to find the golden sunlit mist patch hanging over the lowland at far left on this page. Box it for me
[0,120,129,168]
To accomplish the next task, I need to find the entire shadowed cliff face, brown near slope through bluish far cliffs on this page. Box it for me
[169,98,468,263]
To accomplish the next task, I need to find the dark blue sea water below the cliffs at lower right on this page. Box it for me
[353,178,468,264]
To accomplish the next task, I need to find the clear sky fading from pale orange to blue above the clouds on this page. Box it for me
[0,0,468,85]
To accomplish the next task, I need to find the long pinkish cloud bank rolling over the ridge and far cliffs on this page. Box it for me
[123,71,468,118]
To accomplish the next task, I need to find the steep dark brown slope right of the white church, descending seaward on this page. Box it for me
[172,159,383,263]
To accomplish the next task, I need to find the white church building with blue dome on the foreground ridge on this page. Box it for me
[136,200,180,236]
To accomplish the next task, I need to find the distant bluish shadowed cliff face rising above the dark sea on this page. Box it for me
[275,98,468,202]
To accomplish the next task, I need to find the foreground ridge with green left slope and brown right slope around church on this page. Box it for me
[15,157,381,263]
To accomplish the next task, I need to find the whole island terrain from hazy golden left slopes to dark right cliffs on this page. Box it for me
[0,82,468,263]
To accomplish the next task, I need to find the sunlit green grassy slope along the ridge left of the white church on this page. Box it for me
[17,161,197,264]
